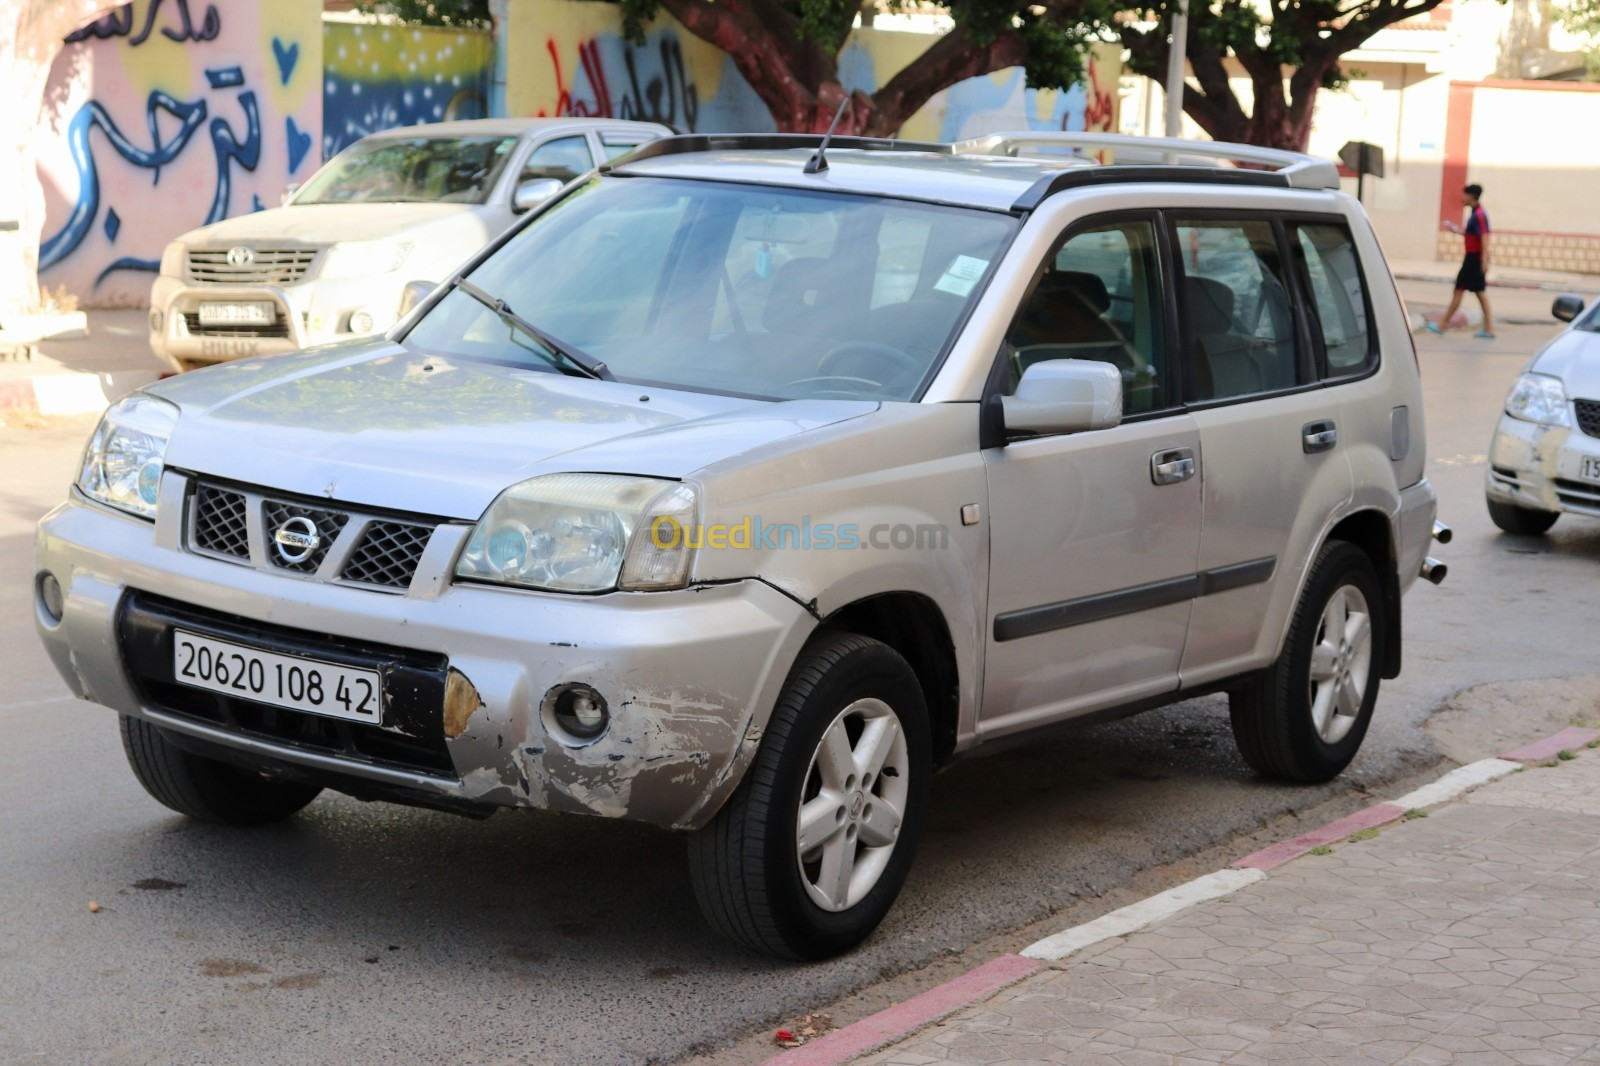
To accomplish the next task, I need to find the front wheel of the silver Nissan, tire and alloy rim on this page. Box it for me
[690,632,933,959]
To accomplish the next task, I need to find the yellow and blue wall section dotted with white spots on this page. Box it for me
[322,16,494,158]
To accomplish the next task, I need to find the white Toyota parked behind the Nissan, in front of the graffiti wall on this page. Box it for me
[150,118,672,370]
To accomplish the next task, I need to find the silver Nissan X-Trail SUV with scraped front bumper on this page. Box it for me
[35,134,1442,957]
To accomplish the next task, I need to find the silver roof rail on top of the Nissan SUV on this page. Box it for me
[950,131,1339,189]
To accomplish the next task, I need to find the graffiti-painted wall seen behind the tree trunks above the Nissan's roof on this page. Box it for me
[506,0,1122,141]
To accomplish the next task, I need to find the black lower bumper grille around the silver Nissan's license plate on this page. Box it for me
[117,592,456,778]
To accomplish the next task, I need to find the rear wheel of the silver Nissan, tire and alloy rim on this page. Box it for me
[1229,541,1387,784]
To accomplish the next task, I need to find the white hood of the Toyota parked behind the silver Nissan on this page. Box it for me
[182,203,493,245]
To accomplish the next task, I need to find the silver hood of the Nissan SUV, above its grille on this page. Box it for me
[147,341,878,520]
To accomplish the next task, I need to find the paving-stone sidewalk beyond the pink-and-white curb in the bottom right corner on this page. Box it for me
[861,751,1600,1066]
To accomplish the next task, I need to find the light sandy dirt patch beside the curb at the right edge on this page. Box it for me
[1422,674,1600,763]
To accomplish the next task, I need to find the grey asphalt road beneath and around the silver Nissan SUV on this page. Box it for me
[0,300,1600,1064]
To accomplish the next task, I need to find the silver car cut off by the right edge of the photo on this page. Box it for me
[1485,295,1600,533]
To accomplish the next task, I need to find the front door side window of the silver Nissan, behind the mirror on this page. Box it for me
[1005,221,1174,415]
